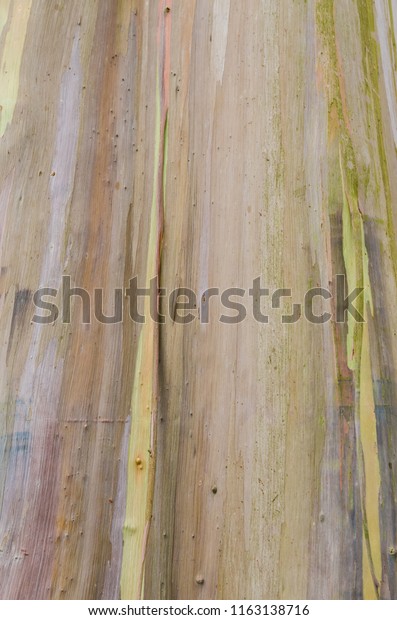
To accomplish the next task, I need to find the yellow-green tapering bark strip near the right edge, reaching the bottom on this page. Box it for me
[340,153,382,599]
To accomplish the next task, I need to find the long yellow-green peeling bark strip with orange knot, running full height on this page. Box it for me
[121,0,171,599]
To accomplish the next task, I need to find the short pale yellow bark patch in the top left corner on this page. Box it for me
[0,0,32,137]
